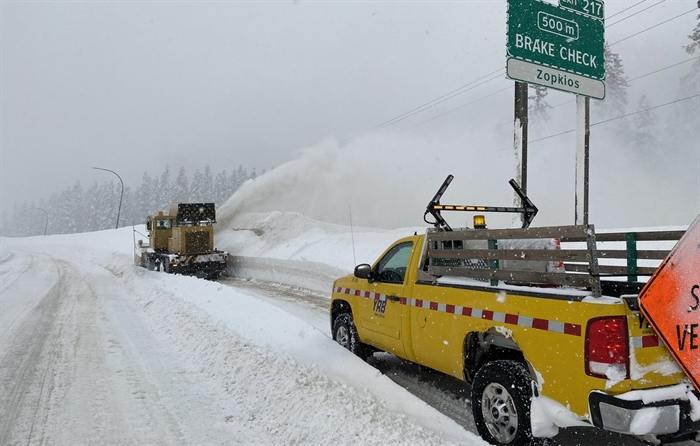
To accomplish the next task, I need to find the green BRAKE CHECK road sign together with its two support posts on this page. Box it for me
[506,0,605,225]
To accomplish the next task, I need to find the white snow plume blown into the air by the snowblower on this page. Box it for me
[218,135,512,228]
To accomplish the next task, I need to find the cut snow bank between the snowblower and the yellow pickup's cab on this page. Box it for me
[216,211,425,298]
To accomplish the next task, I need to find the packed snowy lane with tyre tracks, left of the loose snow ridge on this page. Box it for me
[0,252,260,445]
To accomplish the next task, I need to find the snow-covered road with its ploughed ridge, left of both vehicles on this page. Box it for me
[0,229,485,445]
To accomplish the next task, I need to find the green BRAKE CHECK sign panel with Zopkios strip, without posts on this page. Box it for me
[506,0,605,99]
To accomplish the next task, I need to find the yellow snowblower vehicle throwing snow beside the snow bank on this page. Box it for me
[134,203,228,279]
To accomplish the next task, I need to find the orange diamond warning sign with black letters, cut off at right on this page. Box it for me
[639,216,700,391]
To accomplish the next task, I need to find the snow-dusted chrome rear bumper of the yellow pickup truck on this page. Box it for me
[588,386,700,437]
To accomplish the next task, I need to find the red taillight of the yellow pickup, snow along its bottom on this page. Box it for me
[586,316,629,381]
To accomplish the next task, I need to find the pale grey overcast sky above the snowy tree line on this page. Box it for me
[0,0,700,228]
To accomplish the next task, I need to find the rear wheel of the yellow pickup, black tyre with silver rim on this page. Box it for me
[472,360,551,446]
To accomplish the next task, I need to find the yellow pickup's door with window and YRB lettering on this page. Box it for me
[359,242,413,356]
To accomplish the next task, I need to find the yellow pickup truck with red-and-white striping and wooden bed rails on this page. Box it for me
[330,178,700,446]
